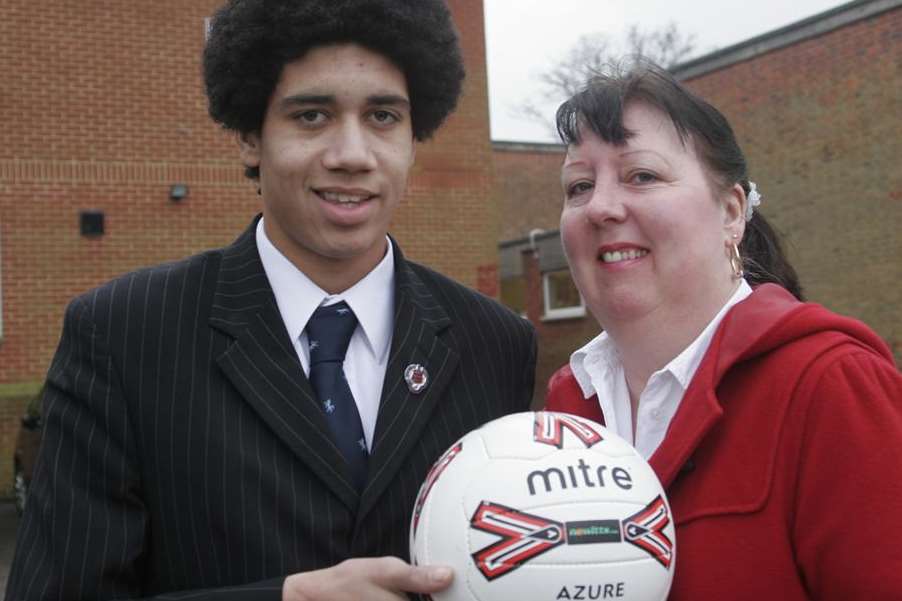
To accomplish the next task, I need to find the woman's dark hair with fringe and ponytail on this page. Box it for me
[556,60,803,300]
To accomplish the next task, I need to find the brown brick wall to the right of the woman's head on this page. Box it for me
[687,8,902,362]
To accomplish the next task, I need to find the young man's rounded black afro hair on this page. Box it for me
[203,0,464,178]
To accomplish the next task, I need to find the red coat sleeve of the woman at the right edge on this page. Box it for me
[791,350,902,601]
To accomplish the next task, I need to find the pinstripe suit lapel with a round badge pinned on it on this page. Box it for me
[357,243,459,523]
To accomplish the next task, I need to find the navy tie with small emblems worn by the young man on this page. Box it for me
[307,302,369,490]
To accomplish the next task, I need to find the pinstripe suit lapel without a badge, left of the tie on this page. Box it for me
[210,220,359,509]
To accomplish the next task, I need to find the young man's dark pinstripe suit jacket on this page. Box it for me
[7,220,535,600]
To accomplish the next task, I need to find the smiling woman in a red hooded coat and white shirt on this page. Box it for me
[547,65,902,601]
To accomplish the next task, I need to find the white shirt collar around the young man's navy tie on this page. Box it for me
[256,218,395,369]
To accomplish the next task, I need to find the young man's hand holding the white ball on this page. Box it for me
[282,557,453,601]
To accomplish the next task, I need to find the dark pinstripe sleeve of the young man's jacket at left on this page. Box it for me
[6,298,284,601]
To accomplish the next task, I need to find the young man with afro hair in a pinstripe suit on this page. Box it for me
[7,0,535,601]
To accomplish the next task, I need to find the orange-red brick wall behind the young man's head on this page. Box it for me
[0,0,498,492]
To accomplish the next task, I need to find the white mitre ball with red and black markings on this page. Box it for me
[410,412,676,601]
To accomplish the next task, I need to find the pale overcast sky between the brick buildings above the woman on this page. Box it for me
[484,0,845,142]
